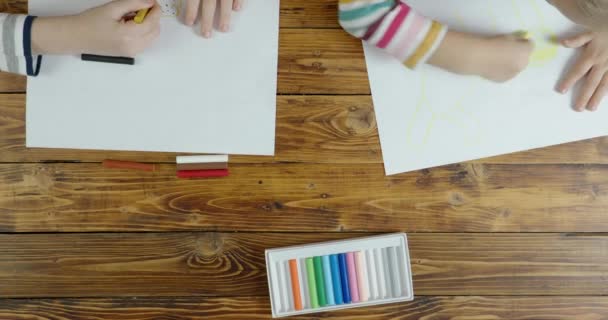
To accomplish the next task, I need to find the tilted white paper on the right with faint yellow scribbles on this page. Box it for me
[365,0,608,175]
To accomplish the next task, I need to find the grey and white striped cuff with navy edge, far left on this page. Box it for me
[0,13,42,76]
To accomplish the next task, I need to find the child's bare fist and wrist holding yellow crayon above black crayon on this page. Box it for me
[32,0,161,57]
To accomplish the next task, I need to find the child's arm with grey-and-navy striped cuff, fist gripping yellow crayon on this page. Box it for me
[0,0,161,76]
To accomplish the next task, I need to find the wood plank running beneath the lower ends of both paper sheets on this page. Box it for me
[0,94,608,164]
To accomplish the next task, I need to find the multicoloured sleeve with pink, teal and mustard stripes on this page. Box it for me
[339,0,447,69]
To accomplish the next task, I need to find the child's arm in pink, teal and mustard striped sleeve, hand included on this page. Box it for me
[339,0,533,82]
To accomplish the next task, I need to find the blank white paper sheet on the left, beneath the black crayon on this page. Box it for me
[26,0,279,155]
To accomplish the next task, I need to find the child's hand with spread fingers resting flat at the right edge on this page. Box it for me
[558,31,608,111]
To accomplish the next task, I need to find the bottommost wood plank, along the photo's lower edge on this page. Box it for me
[0,296,608,320]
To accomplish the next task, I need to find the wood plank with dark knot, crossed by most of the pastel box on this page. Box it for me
[0,232,608,298]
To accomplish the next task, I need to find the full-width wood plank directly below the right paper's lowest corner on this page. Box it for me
[0,164,608,232]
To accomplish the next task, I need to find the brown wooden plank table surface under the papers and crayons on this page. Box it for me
[0,0,608,320]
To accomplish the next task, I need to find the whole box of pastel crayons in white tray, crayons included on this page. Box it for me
[266,233,414,318]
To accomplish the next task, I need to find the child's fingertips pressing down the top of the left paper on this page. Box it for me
[185,0,244,38]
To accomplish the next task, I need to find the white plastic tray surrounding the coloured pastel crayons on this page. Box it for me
[266,233,414,318]
